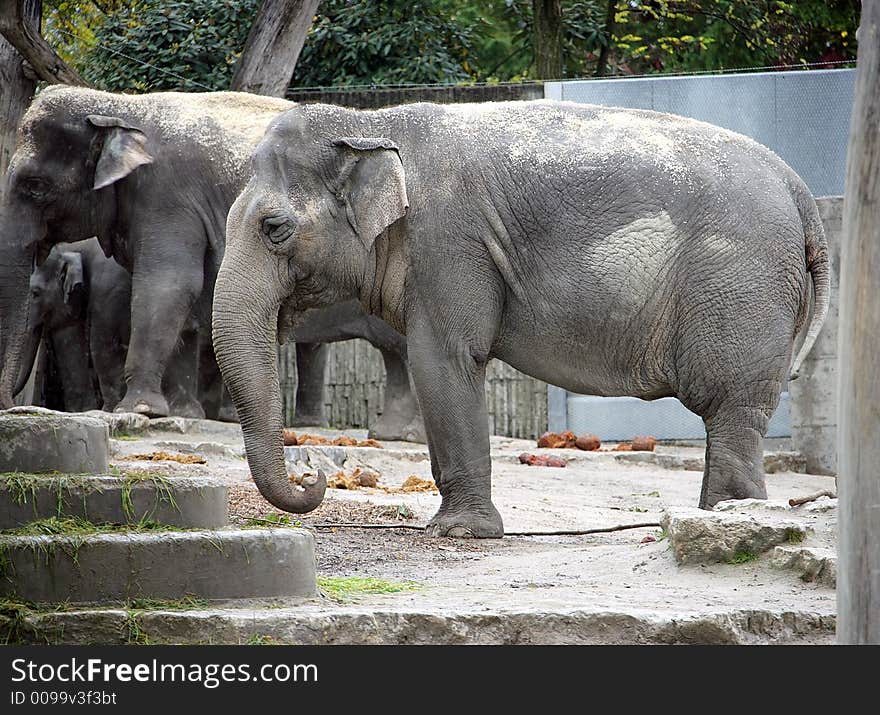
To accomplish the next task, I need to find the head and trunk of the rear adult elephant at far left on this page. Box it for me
[0,87,153,408]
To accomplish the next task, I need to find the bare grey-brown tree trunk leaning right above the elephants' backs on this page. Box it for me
[232,0,320,97]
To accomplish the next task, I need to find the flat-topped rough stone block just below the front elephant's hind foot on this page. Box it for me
[660,508,806,564]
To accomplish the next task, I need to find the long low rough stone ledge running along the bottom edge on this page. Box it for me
[0,602,836,645]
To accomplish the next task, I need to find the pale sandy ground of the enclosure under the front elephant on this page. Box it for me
[105,423,836,632]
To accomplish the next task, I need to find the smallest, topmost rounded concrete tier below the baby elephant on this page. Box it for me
[0,407,110,474]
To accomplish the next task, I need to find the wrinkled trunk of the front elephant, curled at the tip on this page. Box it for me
[213,262,327,514]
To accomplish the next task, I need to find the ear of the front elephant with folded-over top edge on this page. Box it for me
[333,137,409,248]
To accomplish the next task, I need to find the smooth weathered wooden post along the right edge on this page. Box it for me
[837,0,880,644]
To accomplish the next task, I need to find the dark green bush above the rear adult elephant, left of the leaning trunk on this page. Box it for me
[78,0,259,92]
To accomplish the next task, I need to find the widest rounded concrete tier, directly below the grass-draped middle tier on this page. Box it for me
[0,529,317,603]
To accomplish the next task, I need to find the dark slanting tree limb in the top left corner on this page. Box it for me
[0,0,89,87]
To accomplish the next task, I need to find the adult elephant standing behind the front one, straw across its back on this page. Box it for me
[0,86,422,440]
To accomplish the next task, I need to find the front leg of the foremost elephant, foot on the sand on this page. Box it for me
[407,318,504,539]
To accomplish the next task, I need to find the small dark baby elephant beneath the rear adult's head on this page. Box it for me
[15,238,131,412]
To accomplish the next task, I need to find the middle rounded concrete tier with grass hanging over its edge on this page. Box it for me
[0,474,228,529]
